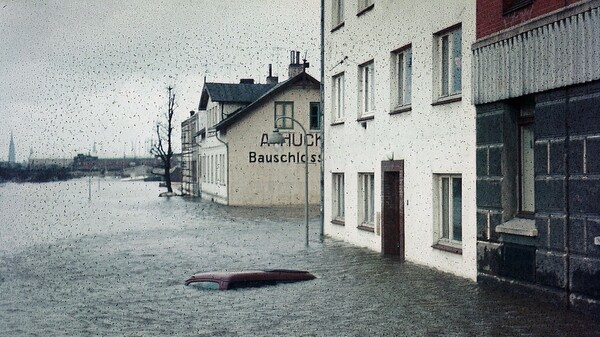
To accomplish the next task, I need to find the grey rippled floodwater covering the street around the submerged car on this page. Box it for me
[0,178,600,337]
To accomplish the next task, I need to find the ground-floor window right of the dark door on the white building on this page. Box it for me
[435,175,462,246]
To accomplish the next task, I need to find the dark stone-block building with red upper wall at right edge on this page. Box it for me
[472,0,600,313]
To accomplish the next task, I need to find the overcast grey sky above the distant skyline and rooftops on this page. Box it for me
[0,0,320,162]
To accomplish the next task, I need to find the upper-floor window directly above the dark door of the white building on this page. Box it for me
[392,46,412,108]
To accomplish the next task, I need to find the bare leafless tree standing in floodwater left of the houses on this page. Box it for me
[150,87,175,193]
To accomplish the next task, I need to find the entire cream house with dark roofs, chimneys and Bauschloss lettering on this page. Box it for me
[182,52,320,206]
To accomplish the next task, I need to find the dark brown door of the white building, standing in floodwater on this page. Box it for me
[381,161,404,259]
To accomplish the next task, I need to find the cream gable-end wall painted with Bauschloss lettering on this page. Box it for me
[215,72,321,206]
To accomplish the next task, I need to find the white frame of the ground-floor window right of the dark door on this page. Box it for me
[433,174,464,253]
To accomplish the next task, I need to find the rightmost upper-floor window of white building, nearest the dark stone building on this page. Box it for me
[434,26,462,98]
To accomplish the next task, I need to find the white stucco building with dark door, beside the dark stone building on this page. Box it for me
[324,0,476,280]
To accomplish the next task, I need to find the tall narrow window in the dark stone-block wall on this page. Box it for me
[518,104,535,214]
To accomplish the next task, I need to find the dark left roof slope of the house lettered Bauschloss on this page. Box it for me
[198,83,275,110]
